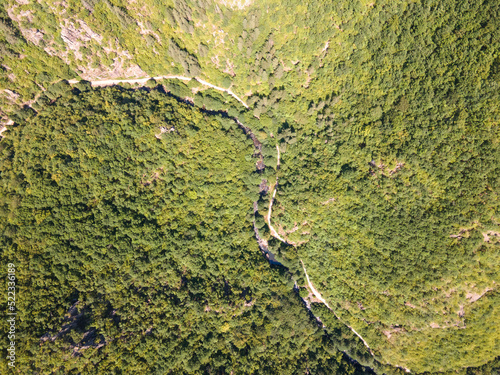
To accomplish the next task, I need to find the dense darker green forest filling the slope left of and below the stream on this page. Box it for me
[0,87,372,374]
